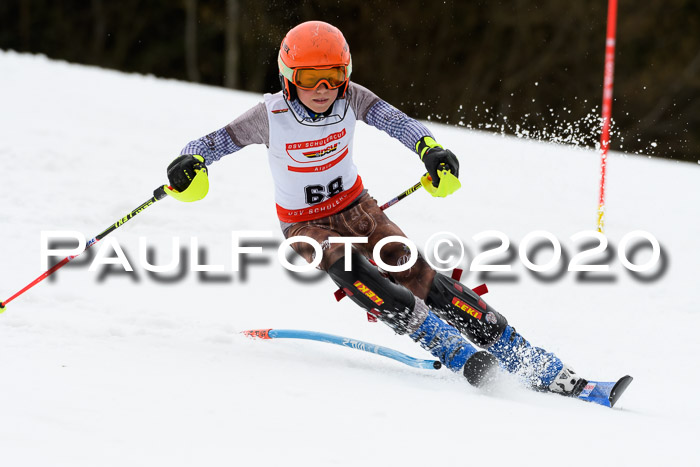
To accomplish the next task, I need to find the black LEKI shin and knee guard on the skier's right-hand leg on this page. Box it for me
[425,273,508,347]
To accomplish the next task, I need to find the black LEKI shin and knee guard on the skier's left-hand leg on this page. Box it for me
[328,251,425,334]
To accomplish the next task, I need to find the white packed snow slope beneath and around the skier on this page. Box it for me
[0,52,700,467]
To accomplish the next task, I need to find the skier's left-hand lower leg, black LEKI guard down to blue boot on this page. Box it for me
[328,252,497,386]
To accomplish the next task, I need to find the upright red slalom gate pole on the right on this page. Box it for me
[598,0,617,233]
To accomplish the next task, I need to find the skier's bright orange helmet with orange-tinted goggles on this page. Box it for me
[277,21,352,99]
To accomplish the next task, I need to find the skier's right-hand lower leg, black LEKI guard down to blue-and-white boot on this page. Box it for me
[426,273,586,395]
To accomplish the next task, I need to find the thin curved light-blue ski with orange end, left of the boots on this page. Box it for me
[242,329,442,370]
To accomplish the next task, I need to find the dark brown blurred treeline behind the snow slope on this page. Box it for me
[0,0,700,163]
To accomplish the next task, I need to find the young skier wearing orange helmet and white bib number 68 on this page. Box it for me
[167,21,587,396]
